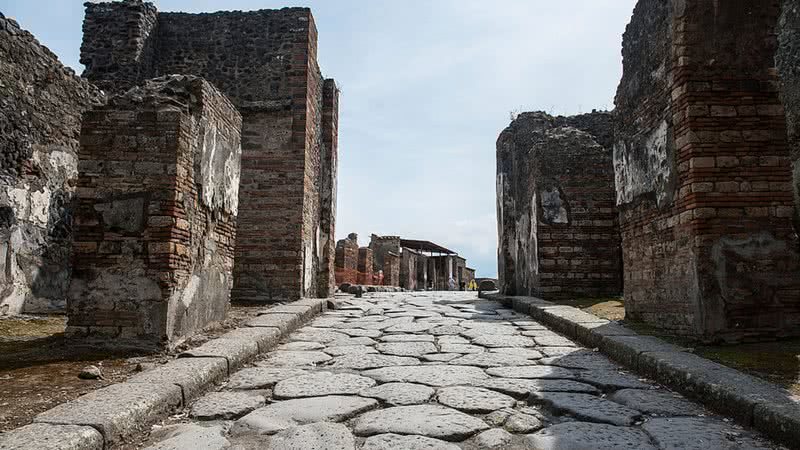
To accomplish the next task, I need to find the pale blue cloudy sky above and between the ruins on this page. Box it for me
[0,0,635,276]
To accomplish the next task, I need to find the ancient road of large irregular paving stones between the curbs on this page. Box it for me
[142,292,777,450]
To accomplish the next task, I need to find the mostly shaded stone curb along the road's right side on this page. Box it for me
[481,293,800,449]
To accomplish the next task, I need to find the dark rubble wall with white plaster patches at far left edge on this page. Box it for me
[0,14,103,315]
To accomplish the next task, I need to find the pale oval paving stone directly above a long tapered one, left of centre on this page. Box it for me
[272,372,375,400]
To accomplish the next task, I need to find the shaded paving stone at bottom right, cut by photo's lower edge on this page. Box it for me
[642,417,773,450]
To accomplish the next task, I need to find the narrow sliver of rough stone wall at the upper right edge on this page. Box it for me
[775,0,800,225]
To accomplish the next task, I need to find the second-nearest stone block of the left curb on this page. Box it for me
[34,383,183,446]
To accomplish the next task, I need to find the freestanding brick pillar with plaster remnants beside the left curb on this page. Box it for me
[67,76,241,346]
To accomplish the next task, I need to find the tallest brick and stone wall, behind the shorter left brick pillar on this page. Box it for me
[81,0,338,302]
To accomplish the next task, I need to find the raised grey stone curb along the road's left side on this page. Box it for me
[0,299,337,450]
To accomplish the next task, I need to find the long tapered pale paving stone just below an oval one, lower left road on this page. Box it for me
[231,396,378,435]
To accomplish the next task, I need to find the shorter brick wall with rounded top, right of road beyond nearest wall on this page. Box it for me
[497,112,622,298]
